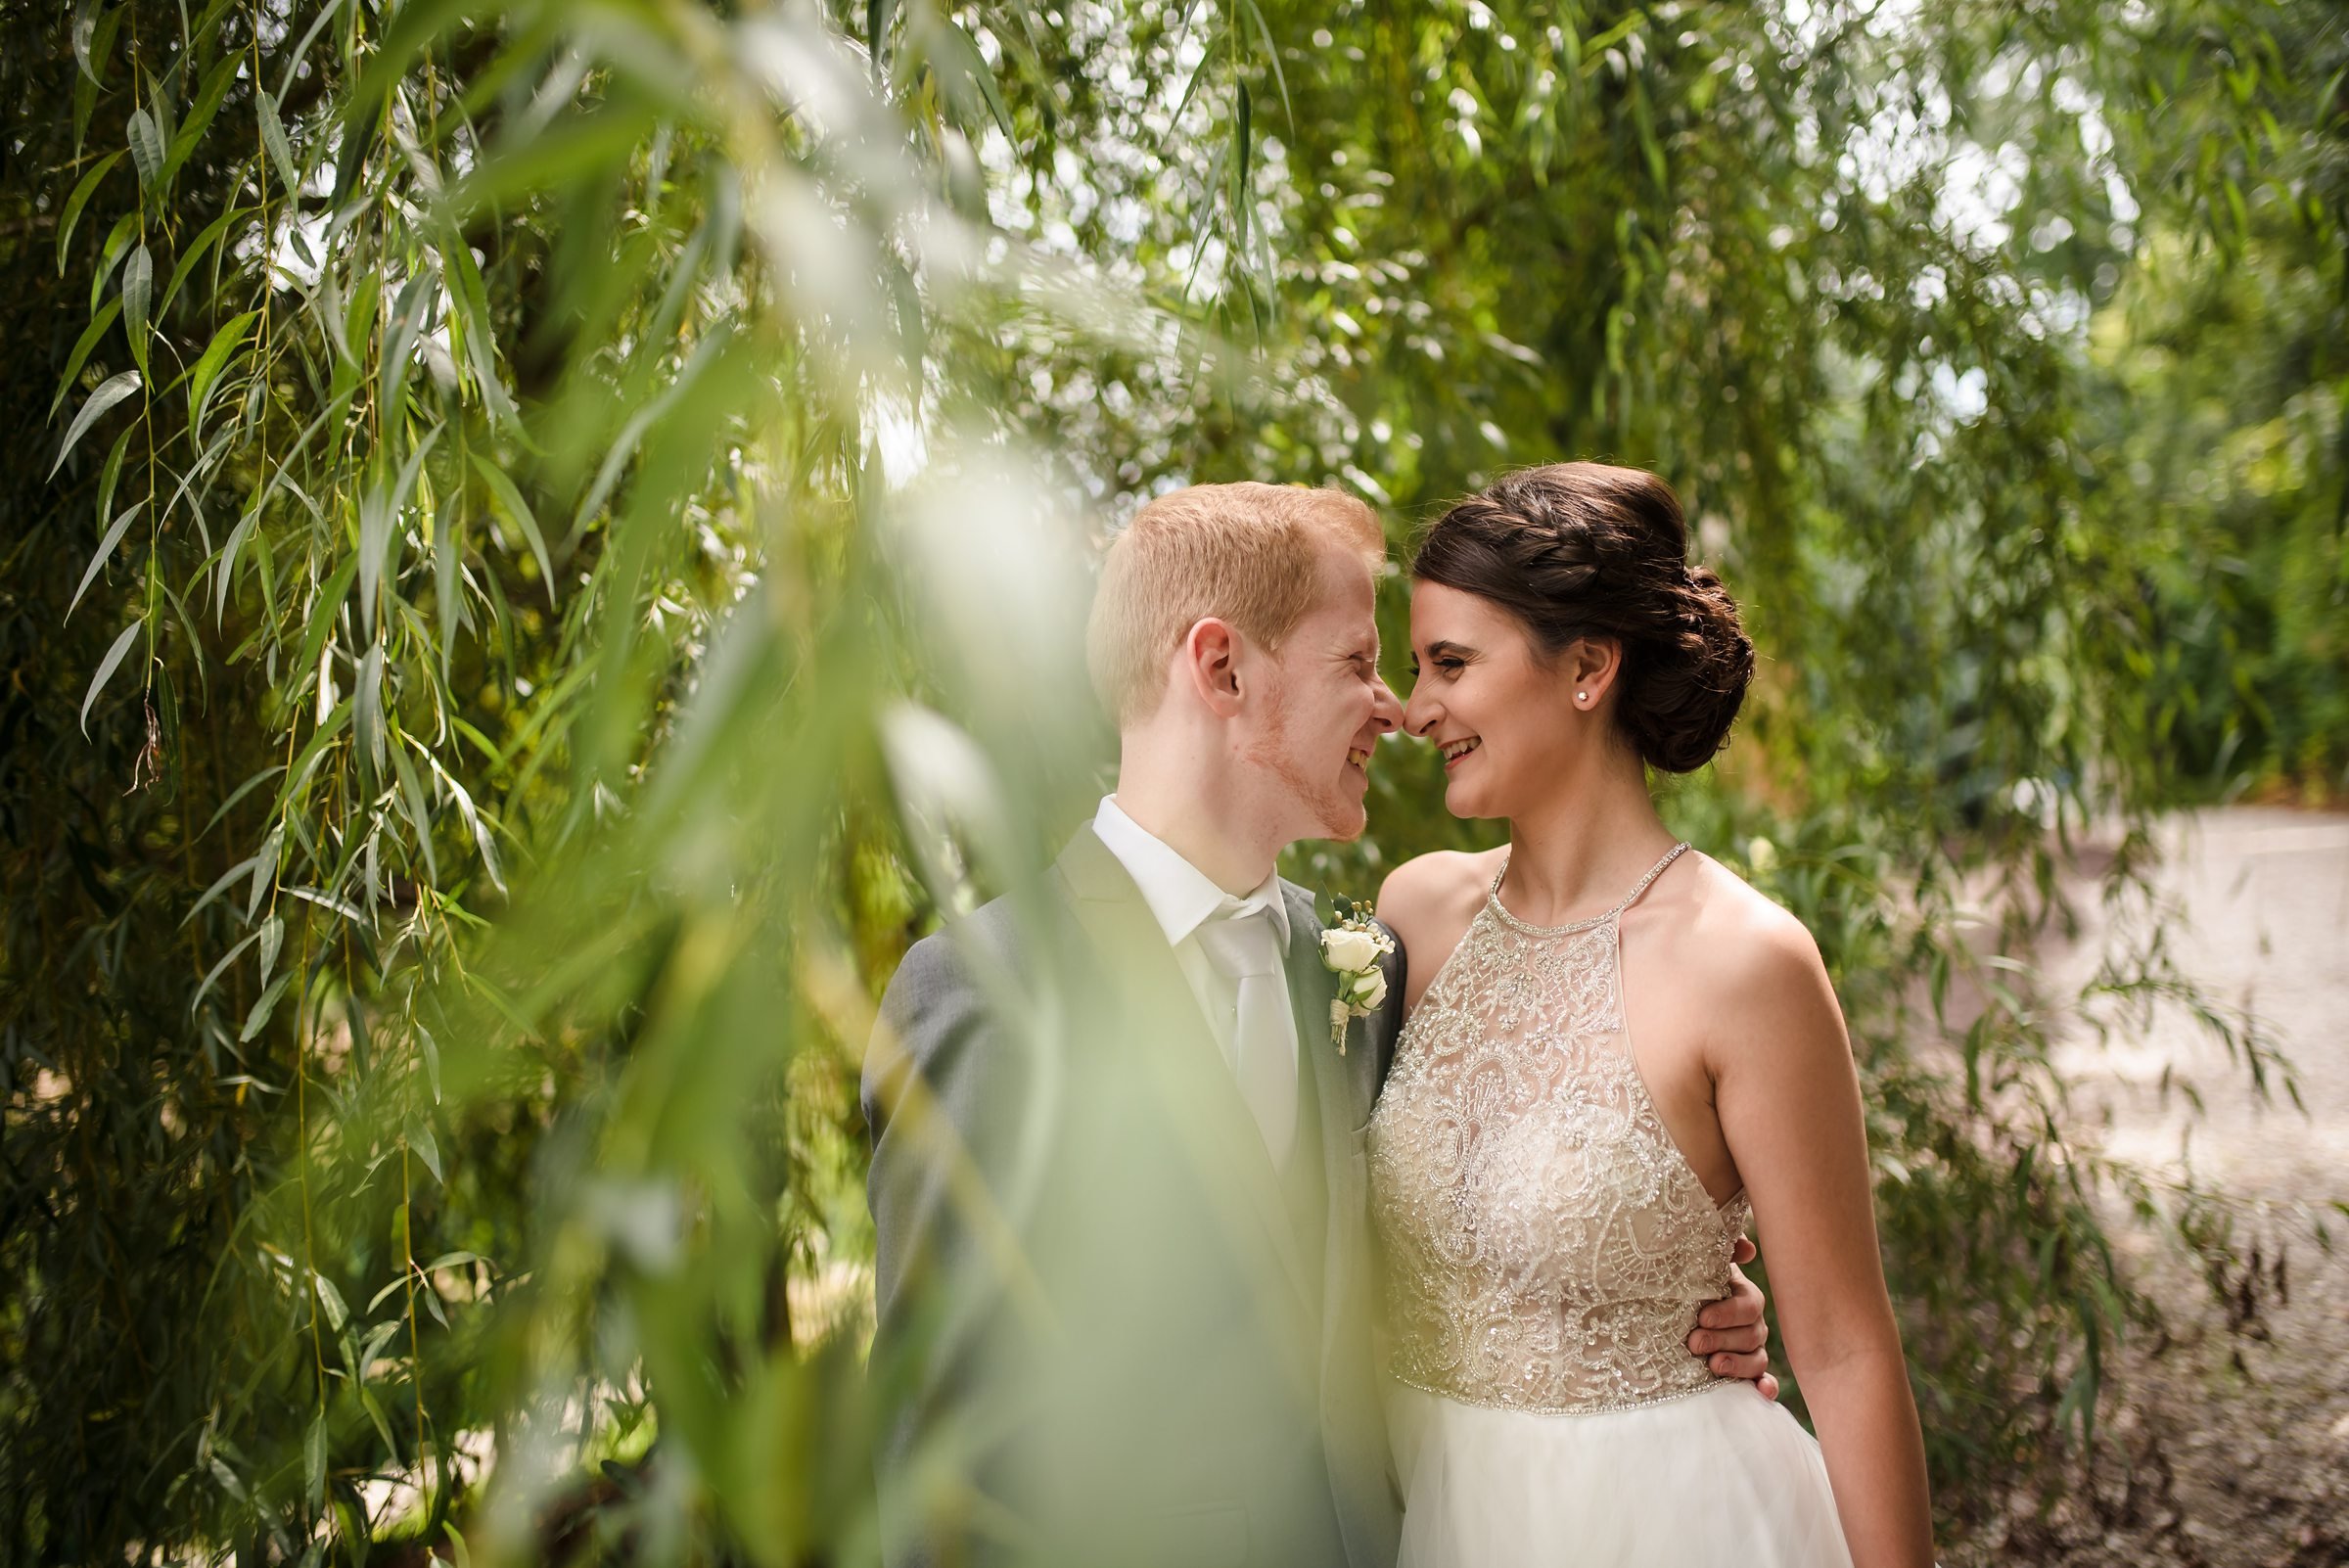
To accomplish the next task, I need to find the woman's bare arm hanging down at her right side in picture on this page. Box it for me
[1713,908,1933,1568]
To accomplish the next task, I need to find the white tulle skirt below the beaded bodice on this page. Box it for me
[1388,1383,1851,1568]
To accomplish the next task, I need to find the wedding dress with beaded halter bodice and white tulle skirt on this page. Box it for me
[1367,845,1851,1568]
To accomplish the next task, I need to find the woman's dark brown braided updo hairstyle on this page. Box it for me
[1411,462,1755,772]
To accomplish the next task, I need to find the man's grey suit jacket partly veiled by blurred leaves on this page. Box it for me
[864,829,1403,1568]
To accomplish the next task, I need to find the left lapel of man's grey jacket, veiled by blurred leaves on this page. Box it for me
[1059,826,1327,1313]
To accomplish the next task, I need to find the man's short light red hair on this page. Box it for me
[1085,482,1386,723]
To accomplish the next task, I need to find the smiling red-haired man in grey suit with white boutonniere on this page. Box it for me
[864,484,1767,1568]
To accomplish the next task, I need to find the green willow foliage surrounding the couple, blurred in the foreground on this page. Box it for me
[0,0,2349,1563]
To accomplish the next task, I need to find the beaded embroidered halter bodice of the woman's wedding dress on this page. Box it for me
[1369,845,1750,1413]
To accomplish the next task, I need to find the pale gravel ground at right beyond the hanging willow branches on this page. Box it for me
[1995,807,2349,1568]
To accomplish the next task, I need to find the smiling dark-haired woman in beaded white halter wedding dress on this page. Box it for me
[1369,462,1931,1568]
